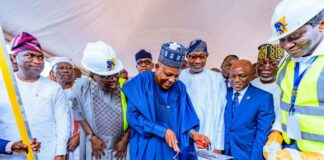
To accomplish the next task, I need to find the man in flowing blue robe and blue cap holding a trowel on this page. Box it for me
[122,42,210,160]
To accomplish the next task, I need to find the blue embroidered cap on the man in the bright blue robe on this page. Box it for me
[159,42,187,68]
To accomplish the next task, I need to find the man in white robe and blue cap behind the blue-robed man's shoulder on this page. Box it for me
[179,40,226,156]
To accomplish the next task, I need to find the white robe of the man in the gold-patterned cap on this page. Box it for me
[251,77,282,132]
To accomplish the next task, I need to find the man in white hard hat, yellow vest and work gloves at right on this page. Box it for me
[264,0,324,160]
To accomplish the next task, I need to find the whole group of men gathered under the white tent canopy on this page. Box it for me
[0,0,324,160]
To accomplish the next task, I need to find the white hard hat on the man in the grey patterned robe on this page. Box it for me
[81,41,124,76]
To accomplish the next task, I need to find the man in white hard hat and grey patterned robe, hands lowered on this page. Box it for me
[70,41,129,160]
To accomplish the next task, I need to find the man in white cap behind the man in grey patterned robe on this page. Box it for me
[50,57,80,160]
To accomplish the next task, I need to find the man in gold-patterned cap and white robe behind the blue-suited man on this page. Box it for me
[251,44,284,132]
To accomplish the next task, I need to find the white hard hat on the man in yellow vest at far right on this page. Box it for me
[268,0,324,43]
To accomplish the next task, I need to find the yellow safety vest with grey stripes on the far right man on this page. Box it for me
[277,55,324,152]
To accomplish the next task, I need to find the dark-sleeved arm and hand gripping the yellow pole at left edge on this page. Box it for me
[0,139,40,154]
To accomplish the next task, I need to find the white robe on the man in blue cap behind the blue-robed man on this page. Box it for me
[179,68,227,150]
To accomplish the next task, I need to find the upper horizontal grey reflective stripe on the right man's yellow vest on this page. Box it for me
[280,101,324,115]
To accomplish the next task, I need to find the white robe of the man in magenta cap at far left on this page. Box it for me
[0,74,70,160]
